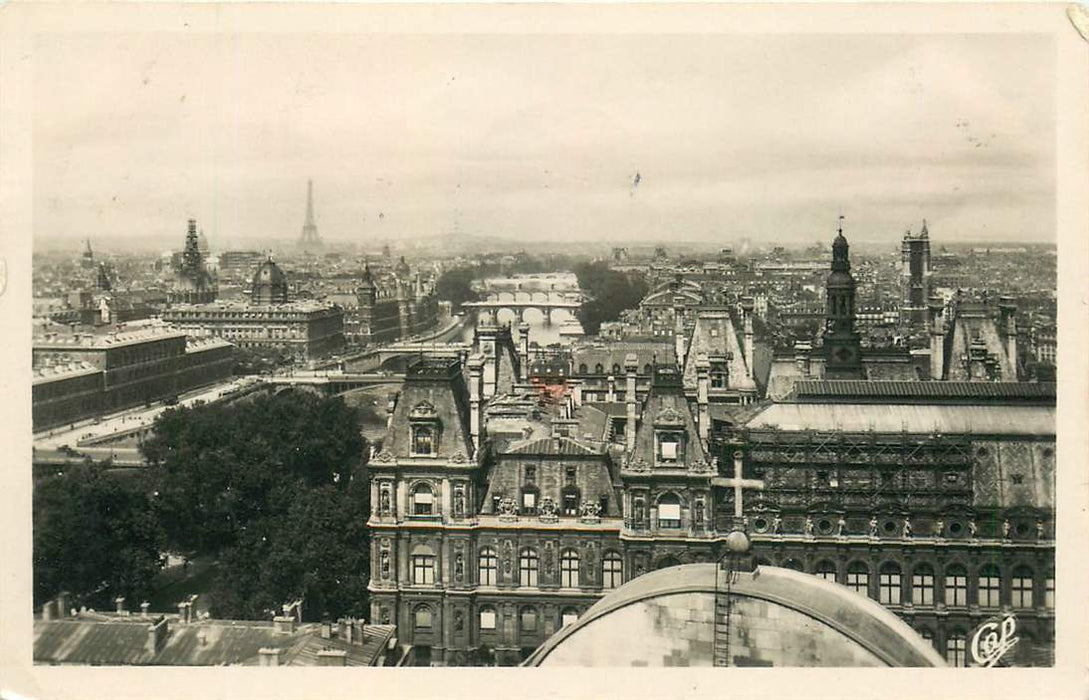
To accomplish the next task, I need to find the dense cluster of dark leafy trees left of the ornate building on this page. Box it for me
[35,390,369,619]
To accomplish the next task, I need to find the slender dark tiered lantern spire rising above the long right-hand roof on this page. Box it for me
[824,222,864,379]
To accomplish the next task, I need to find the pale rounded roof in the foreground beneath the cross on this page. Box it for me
[524,564,945,666]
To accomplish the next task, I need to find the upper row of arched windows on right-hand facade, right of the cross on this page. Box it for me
[801,560,1055,609]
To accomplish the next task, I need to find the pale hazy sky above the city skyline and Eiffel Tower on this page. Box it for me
[34,34,1055,247]
